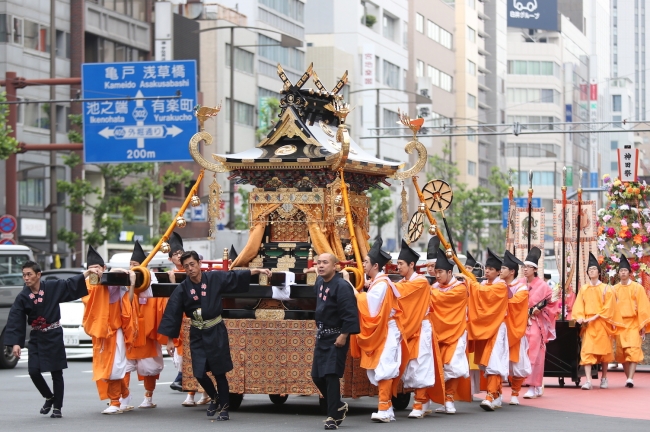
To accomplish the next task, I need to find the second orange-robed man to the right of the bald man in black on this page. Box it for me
[395,239,442,419]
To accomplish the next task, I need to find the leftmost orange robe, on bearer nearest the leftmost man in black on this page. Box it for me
[81,280,134,400]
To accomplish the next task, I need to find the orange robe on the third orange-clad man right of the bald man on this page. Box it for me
[429,281,472,402]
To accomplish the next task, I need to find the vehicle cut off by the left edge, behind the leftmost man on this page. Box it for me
[0,245,34,369]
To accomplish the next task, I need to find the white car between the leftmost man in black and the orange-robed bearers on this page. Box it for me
[41,268,93,358]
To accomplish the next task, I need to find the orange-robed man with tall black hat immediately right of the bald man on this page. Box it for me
[353,237,406,423]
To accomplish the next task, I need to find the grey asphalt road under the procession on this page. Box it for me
[0,358,650,432]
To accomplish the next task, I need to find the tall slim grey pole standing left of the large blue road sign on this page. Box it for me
[49,0,59,268]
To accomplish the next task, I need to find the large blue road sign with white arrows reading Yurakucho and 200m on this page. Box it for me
[81,60,198,163]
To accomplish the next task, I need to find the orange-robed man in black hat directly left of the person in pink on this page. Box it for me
[499,251,531,405]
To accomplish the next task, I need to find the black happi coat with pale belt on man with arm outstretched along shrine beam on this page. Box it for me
[158,270,251,378]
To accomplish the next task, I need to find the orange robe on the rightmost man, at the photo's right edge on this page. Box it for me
[614,281,650,363]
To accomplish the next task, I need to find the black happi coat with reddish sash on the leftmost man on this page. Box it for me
[4,274,88,372]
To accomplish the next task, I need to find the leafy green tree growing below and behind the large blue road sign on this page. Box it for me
[57,115,192,247]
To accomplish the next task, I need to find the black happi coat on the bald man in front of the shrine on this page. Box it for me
[311,273,360,378]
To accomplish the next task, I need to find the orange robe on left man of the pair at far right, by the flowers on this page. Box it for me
[572,282,623,365]
